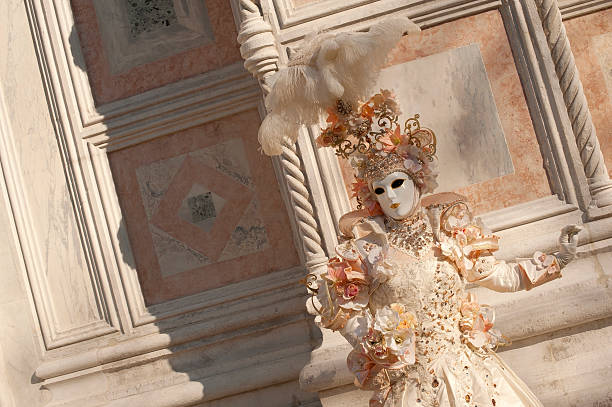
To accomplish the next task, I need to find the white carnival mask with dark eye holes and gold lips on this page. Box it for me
[372,171,420,220]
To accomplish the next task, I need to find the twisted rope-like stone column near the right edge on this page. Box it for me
[535,0,612,207]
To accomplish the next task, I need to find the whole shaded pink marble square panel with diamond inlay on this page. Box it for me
[109,110,299,304]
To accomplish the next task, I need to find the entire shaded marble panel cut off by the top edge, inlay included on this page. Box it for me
[71,0,241,105]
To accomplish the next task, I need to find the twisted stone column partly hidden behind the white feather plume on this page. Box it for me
[238,0,327,273]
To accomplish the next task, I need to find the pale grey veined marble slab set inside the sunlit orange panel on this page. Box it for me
[379,44,514,191]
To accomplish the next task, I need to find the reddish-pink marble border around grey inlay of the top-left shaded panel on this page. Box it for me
[71,0,241,105]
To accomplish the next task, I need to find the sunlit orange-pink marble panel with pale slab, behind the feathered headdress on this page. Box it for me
[342,11,551,217]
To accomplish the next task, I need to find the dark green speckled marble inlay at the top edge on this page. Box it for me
[127,0,177,38]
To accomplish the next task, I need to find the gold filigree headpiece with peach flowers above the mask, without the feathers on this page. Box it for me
[317,90,437,217]
